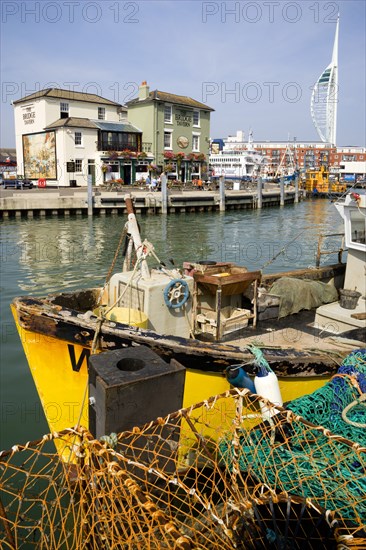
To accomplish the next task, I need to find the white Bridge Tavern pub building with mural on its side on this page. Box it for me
[13,88,148,187]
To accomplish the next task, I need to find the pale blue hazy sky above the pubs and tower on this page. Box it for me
[0,0,366,148]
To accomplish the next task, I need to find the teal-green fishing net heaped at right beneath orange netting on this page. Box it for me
[220,349,366,523]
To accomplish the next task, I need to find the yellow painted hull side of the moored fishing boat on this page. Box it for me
[12,306,330,442]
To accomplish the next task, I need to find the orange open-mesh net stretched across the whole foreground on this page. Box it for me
[0,389,366,550]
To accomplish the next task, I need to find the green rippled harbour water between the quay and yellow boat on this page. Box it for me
[0,200,343,449]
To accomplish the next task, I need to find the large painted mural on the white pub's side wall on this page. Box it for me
[23,132,57,179]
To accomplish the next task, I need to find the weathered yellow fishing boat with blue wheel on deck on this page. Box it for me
[11,195,365,440]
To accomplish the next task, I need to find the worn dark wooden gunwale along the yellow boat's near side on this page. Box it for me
[12,289,347,378]
